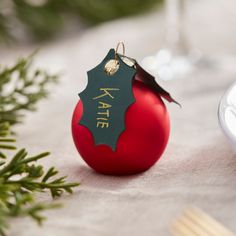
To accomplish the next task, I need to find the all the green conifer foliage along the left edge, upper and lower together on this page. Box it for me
[0,56,79,236]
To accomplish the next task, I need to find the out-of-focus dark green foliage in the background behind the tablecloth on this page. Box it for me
[0,0,163,43]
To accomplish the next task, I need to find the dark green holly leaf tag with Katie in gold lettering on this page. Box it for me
[79,49,136,151]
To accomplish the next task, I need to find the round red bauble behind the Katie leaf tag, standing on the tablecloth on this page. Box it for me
[72,80,170,175]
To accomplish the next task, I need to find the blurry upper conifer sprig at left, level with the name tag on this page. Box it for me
[0,55,58,125]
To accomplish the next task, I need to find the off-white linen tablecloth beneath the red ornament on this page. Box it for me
[1,1,236,236]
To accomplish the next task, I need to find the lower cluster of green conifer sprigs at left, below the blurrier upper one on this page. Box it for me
[0,149,79,232]
